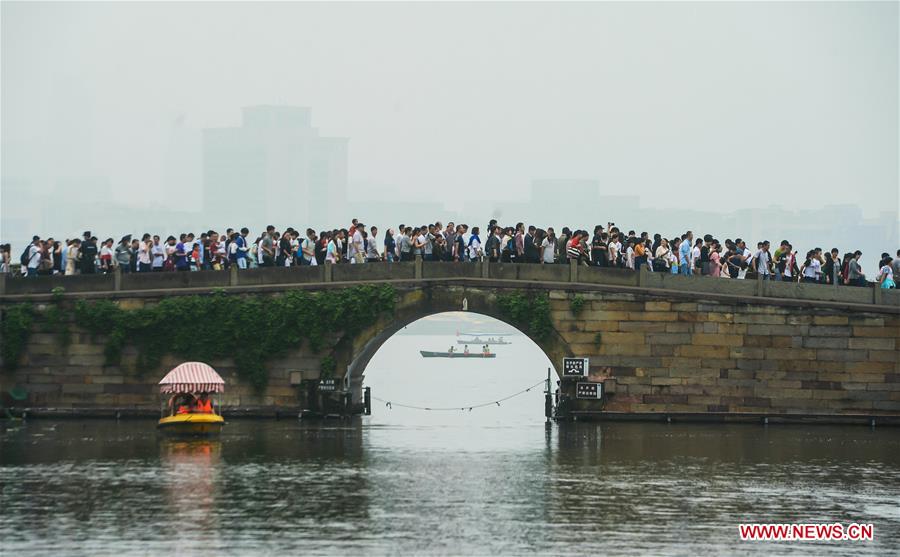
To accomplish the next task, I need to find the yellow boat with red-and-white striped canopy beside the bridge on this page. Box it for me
[157,362,225,435]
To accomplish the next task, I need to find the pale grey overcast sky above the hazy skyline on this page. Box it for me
[2,2,900,219]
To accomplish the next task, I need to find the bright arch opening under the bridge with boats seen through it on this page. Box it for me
[350,311,557,426]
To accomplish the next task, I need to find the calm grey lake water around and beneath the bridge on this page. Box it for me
[0,314,900,557]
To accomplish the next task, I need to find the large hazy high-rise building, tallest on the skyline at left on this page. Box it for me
[203,106,348,228]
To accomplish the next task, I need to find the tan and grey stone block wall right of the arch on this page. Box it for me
[572,294,900,416]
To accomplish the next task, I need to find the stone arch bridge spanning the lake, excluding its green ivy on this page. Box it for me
[0,261,900,422]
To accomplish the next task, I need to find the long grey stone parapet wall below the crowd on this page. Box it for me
[0,261,900,310]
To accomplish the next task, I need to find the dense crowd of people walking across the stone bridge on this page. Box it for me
[0,219,900,288]
